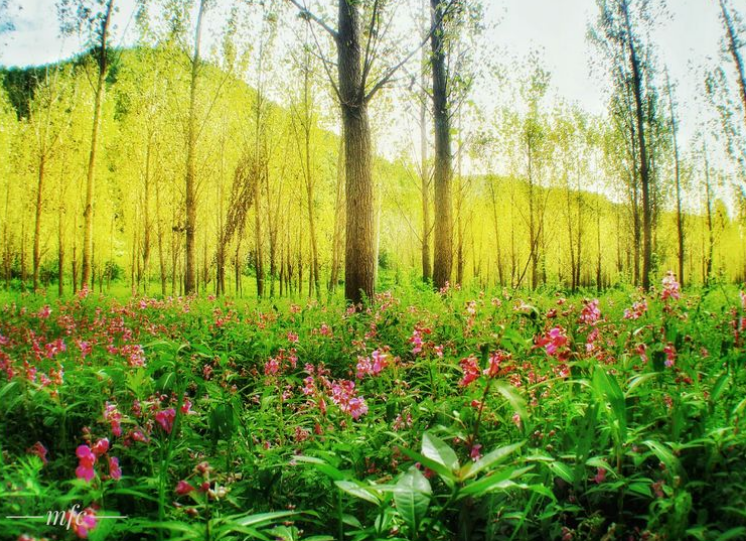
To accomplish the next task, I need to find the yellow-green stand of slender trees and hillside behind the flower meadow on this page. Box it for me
[0,0,746,302]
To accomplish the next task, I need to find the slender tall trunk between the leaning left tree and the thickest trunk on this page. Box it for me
[184,0,205,295]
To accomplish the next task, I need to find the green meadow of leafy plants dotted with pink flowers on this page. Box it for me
[0,275,746,541]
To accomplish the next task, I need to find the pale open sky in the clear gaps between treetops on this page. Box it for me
[0,0,722,150]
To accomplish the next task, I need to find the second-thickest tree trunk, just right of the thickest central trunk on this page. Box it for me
[430,0,453,289]
